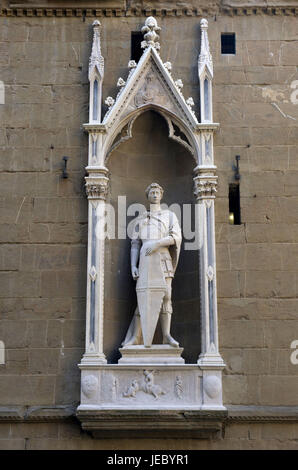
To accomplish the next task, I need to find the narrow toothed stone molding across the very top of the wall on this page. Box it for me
[0,4,298,18]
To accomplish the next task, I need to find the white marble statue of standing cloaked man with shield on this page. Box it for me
[122,183,181,347]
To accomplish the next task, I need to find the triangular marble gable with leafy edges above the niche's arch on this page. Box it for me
[102,38,198,134]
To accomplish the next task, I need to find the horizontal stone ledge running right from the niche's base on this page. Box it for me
[227,405,298,424]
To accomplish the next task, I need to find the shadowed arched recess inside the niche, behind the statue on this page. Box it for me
[104,111,200,363]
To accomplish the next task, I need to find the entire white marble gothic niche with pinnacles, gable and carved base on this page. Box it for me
[77,17,226,437]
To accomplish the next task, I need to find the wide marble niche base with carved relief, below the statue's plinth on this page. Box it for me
[77,362,227,439]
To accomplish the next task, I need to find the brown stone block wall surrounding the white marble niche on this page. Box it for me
[0,4,298,449]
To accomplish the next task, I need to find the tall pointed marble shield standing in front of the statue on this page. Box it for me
[136,246,166,348]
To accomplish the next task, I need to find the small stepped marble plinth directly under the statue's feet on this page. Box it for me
[118,344,185,365]
